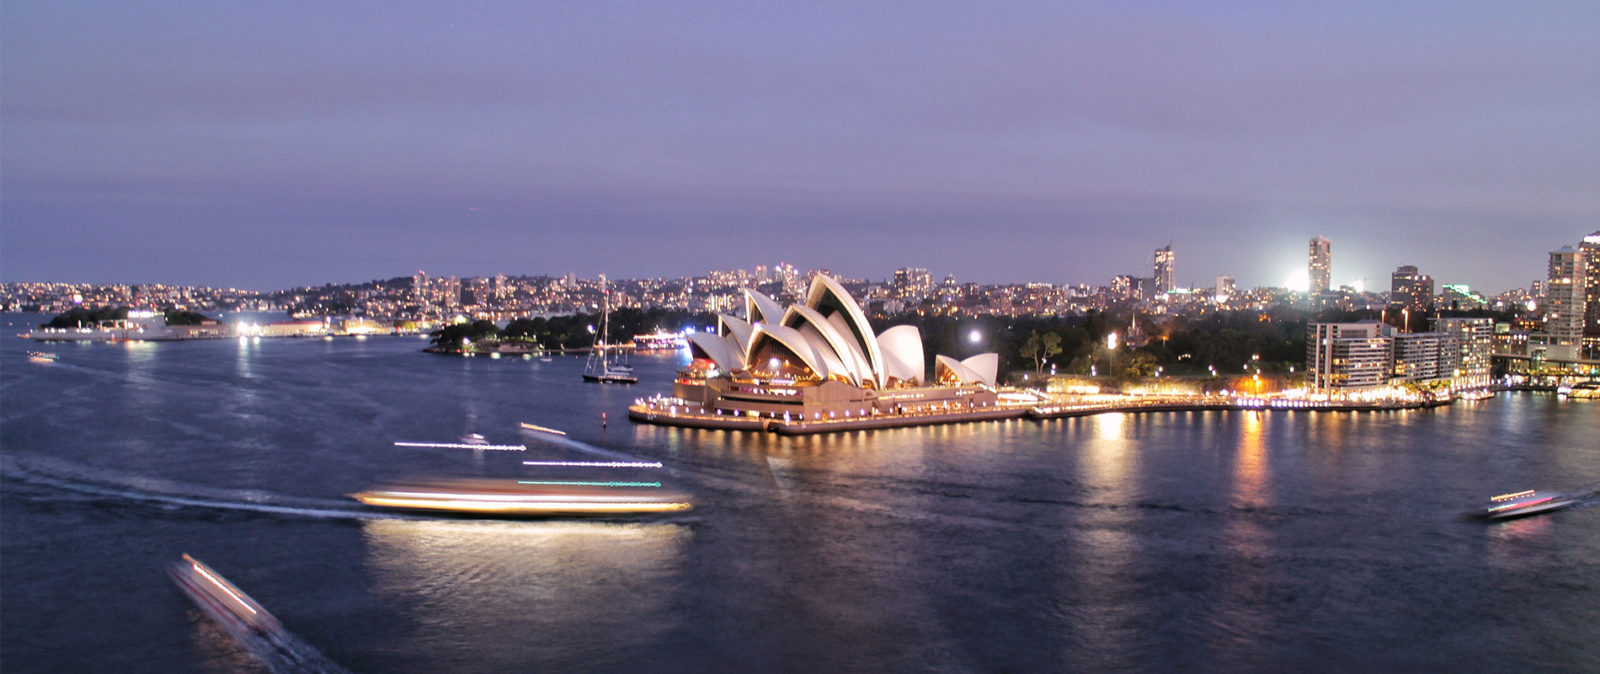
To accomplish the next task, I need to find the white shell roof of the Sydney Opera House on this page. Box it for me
[690,274,1000,389]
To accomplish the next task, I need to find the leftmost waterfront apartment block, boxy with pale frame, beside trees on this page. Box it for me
[1306,320,1394,394]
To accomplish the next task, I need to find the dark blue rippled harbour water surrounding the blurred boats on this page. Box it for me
[0,315,1600,672]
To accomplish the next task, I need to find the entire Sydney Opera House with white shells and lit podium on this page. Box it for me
[629,275,1014,432]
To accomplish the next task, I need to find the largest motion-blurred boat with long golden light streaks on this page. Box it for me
[350,477,694,517]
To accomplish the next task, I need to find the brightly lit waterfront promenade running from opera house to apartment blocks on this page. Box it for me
[627,391,1454,435]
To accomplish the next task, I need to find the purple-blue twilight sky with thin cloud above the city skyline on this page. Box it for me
[0,0,1600,293]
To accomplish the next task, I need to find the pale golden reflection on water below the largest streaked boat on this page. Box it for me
[363,520,690,671]
